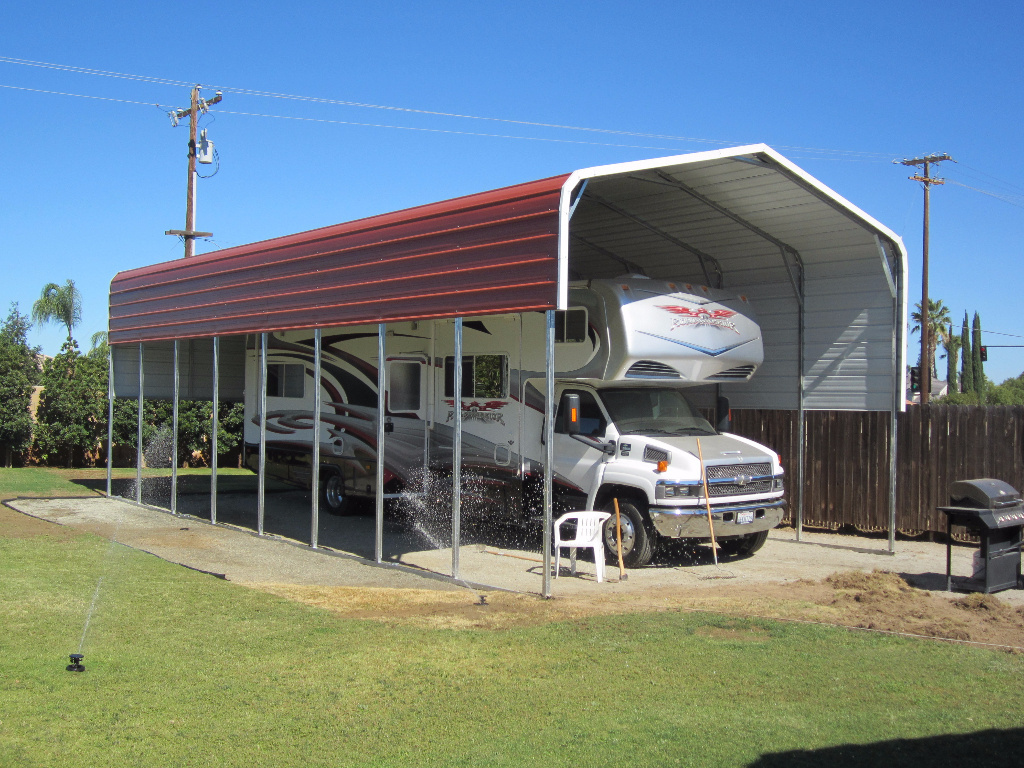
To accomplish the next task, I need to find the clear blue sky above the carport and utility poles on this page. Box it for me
[0,0,1024,381]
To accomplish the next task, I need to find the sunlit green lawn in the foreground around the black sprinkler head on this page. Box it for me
[0,531,1024,768]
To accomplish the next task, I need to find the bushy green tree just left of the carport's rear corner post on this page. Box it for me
[36,338,108,467]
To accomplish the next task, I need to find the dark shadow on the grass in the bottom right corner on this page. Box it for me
[749,728,1024,768]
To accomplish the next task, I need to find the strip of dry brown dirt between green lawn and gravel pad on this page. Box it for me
[243,570,1024,648]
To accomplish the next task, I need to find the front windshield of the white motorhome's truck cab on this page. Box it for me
[600,387,717,435]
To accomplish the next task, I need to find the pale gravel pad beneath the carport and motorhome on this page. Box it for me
[7,492,1024,605]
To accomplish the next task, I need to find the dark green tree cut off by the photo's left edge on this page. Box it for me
[0,302,39,467]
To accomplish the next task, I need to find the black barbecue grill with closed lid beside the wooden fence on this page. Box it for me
[939,477,1024,594]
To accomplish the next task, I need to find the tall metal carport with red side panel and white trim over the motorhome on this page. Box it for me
[110,144,907,593]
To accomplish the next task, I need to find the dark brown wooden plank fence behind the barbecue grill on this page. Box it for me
[732,404,1024,535]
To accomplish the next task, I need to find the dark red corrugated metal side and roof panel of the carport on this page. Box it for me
[110,175,568,344]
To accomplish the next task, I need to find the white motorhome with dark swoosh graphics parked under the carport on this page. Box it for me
[246,275,783,566]
